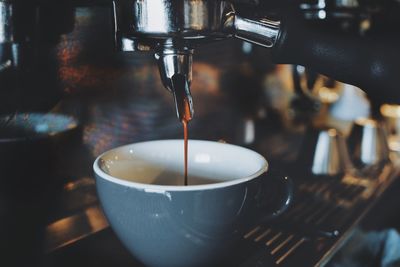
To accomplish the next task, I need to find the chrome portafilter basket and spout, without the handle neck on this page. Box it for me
[114,0,232,118]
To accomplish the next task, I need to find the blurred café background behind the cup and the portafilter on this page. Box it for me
[0,0,400,267]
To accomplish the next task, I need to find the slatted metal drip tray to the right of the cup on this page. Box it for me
[240,164,399,267]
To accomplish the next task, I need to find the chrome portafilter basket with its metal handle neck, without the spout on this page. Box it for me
[114,0,280,51]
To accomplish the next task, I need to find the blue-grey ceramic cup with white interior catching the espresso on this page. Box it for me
[94,140,292,267]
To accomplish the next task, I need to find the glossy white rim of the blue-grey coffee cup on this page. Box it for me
[93,139,268,193]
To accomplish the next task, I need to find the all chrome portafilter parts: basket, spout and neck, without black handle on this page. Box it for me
[113,0,279,119]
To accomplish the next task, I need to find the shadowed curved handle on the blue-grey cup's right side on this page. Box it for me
[262,169,293,221]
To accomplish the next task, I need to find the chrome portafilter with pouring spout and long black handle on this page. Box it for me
[113,0,400,116]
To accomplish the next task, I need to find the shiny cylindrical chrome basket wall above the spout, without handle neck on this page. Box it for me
[116,0,232,39]
